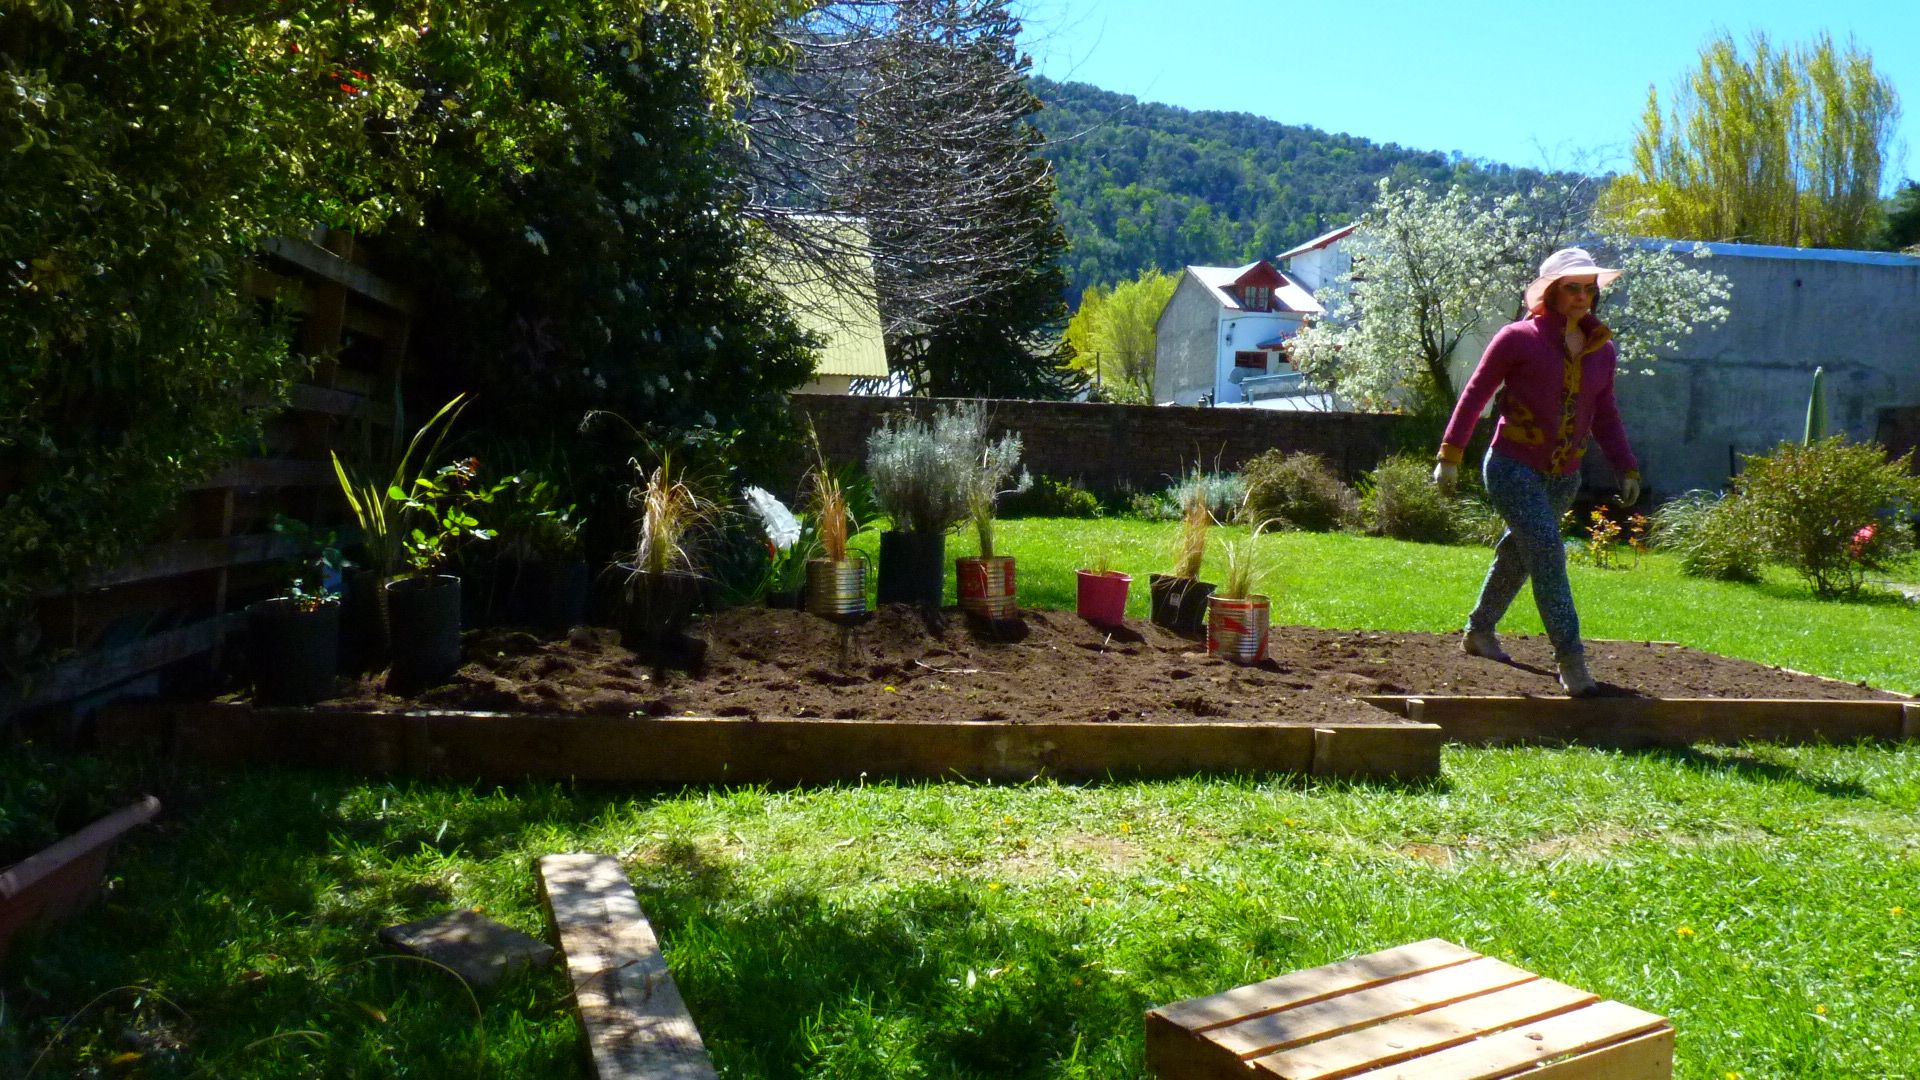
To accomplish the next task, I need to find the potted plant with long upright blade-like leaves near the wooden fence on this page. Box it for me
[332,394,467,671]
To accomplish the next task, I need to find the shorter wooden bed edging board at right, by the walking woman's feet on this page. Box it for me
[1363,694,1920,749]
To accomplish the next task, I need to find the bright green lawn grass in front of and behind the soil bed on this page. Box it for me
[0,521,1920,1080]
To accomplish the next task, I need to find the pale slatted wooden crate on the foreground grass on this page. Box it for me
[1146,938,1674,1080]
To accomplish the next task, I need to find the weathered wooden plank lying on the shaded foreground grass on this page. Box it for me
[538,853,716,1080]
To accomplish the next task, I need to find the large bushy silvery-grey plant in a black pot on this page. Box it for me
[866,404,985,607]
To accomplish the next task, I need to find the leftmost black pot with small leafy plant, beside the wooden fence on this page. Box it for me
[246,515,348,705]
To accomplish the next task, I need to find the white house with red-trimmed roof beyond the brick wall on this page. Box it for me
[1154,259,1325,407]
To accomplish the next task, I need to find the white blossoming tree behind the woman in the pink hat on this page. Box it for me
[1292,179,1730,413]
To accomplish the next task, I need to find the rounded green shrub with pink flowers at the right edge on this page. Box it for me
[1736,436,1920,596]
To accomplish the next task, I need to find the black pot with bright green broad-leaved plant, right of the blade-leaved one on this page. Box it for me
[386,457,511,694]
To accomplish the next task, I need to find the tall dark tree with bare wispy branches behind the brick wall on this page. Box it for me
[747,0,1073,398]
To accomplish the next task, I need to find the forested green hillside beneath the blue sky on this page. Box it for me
[1031,77,1538,304]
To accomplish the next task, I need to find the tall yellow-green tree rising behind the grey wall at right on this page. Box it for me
[1601,33,1901,248]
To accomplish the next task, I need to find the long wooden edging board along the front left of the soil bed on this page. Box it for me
[100,703,1442,784]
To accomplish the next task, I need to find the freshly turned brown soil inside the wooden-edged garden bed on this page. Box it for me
[307,607,1893,723]
